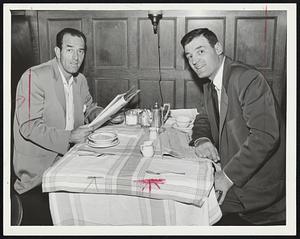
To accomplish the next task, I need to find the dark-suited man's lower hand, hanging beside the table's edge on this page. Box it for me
[215,171,233,205]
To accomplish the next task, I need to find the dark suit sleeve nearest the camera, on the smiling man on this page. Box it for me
[224,70,280,187]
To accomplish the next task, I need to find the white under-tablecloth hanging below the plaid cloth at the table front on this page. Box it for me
[49,187,222,226]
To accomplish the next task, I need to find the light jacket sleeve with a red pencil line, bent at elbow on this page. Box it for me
[16,69,70,155]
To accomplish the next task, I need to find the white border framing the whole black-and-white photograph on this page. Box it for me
[3,3,297,235]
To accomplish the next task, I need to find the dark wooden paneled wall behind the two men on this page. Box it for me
[25,10,286,115]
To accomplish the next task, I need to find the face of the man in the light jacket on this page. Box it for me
[55,34,85,76]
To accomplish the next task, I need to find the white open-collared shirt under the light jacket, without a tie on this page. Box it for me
[58,67,74,130]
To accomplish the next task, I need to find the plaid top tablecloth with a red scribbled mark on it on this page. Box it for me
[43,126,221,226]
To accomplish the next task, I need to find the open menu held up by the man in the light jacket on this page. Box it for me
[88,87,140,129]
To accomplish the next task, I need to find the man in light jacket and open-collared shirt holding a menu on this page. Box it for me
[13,28,101,225]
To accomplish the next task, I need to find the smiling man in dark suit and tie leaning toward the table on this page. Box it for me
[181,28,286,225]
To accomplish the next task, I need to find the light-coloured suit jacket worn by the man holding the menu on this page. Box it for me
[13,58,96,193]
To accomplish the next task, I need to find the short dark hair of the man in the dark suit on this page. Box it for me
[181,28,218,47]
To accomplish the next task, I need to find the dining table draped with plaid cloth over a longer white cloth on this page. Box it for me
[42,113,222,226]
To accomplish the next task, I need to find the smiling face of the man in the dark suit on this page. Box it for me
[184,36,222,80]
